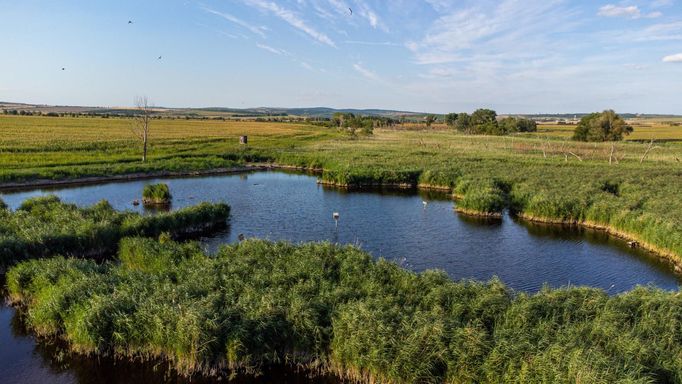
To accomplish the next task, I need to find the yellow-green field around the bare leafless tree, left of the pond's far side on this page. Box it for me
[0,116,328,182]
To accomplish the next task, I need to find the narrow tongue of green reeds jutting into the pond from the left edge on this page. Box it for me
[0,195,230,268]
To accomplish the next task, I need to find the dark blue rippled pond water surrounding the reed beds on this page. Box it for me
[0,172,680,383]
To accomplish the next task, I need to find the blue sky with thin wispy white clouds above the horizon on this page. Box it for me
[0,0,682,114]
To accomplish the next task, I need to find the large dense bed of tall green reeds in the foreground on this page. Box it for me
[7,238,682,383]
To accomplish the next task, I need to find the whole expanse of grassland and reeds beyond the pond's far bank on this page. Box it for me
[0,116,682,264]
